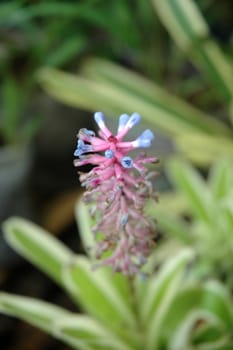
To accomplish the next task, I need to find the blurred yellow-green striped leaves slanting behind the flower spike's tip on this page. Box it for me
[40,59,233,166]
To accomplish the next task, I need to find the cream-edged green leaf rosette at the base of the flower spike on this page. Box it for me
[0,203,233,350]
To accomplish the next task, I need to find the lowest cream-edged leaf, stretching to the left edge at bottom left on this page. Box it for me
[0,293,126,350]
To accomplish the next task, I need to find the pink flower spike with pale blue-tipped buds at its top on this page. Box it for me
[74,112,157,275]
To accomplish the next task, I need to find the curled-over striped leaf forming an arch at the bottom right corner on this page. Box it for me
[162,282,233,350]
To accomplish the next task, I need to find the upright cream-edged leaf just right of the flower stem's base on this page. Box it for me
[138,249,193,350]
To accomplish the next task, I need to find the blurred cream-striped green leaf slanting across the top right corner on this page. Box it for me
[152,0,233,102]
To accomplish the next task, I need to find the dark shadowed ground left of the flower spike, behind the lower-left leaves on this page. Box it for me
[0,100,92,350]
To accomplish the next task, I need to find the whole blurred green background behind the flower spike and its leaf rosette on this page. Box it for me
[0,0,233,350]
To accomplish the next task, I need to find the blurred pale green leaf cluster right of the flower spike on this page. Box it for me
[148,159,233,289]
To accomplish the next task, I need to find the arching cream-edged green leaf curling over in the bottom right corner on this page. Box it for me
[162,282,233,344]
